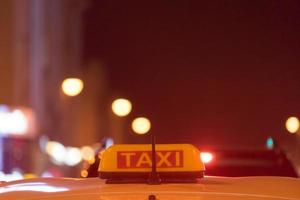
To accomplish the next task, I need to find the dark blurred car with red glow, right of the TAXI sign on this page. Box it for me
[205,150,298,177]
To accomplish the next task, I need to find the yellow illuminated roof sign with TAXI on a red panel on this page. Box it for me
[98,144,205,179]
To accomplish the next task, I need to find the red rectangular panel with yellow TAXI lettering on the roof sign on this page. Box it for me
[117,150,183,169]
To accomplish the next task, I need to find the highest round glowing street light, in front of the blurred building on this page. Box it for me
[61,78,83,97]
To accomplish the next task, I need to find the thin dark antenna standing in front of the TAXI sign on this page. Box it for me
[148,134,161,185]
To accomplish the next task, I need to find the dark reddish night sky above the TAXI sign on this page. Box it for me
[84,0,300,148]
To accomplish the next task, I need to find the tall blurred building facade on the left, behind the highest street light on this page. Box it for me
[0,0,109,176]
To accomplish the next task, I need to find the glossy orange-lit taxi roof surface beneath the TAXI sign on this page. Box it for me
[0,177,300,200]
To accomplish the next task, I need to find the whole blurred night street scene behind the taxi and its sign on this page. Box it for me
[0,0,300,180]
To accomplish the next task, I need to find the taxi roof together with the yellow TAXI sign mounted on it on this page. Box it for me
[0,144,300,200]
